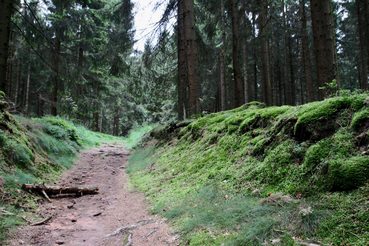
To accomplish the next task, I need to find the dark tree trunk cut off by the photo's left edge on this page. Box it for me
[0,0,13,92]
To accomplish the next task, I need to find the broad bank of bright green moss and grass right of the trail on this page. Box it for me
[128,94,369,245]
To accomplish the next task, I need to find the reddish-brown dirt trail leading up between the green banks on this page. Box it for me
[9,145,178,246]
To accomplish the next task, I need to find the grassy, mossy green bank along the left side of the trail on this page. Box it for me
[0,94,123,242]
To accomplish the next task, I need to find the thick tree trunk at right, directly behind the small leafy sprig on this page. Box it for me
[310,0,337,99]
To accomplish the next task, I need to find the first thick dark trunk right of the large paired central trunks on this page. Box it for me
[229,0,245,107]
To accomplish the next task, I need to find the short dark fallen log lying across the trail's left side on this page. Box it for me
[22,184,99,199]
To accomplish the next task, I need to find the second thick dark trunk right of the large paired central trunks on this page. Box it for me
[259,0,273,105]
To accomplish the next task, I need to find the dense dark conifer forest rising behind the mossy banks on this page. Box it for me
[0,0,369,135]
